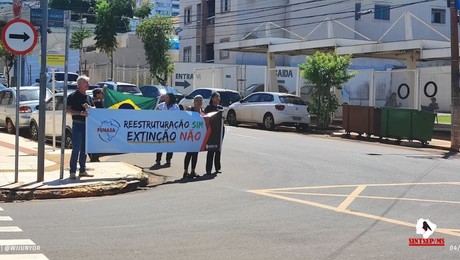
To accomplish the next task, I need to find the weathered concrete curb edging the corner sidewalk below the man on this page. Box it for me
[0,172,166,202]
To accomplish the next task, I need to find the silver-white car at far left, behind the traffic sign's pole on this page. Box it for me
[0,86,52,134]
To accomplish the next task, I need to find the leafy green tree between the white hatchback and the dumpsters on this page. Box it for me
[299,52,354,127]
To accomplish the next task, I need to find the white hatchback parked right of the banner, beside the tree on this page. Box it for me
[227,92,310,131]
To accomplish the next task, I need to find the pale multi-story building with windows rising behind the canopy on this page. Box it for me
[180,0,450,66]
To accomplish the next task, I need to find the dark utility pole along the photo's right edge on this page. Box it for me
[449,0,460,151]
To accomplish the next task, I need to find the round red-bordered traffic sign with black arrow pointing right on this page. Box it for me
[2,18,38,55]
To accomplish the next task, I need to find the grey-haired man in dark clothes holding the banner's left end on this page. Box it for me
[67,76,94,179]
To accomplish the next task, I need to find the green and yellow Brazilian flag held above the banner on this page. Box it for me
[104,88,157,110]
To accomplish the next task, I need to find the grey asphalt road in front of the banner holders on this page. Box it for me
[1,127,460,259]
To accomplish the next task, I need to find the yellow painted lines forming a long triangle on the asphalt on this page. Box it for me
[248,182,460,237]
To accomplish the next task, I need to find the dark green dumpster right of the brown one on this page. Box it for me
[380,107,435,144]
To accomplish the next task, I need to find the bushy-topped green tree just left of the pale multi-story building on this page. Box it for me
[136,15,174,84]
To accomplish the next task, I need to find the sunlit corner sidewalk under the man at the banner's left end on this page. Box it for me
[0,130,163,201]
